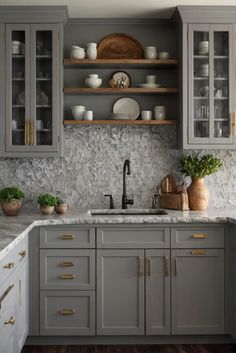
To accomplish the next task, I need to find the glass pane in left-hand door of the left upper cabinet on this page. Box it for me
[11,31,25,145]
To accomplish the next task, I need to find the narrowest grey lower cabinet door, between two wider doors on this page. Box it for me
[146,250,170,335]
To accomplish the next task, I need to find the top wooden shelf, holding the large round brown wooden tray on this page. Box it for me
[64,59,178,68]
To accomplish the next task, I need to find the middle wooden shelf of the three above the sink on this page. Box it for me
[64,87,178,94]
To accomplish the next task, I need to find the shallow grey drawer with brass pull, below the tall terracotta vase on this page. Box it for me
[171,225,225,249]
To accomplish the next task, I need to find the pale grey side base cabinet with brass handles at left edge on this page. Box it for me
[0,235,29,353]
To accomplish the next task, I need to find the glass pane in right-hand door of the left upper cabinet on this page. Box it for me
[36,31,53,145]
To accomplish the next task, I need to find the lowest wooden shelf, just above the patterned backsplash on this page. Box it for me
[64,119,177,125]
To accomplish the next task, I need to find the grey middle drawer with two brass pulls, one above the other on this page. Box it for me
[40,249,95,290]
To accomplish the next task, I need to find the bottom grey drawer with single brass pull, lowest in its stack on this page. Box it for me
[40,291,95,336]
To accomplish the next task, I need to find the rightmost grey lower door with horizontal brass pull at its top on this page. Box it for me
[171,249,225,335]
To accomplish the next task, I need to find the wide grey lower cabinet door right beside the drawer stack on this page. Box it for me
[97,250,144,335]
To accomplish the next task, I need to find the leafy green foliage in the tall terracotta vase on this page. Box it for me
[179,154,223,179]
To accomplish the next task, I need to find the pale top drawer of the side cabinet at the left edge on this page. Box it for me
[0,238,28,287]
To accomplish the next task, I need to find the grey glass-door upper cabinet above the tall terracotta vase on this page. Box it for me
[175,6,236,149]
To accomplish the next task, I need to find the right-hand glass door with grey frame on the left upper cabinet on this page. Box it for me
[31,24,58,151]
